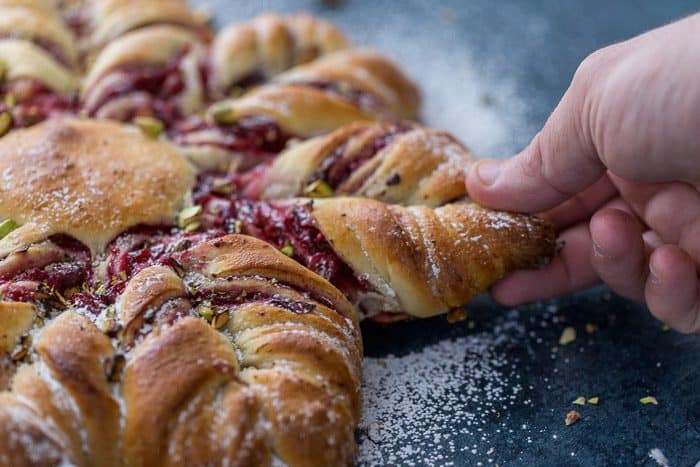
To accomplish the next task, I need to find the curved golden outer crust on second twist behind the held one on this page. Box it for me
[275,49,420,120]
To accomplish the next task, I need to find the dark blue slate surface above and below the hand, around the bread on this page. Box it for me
[201,0,700,466]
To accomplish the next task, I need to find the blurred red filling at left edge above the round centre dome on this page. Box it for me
[0,78,78,128]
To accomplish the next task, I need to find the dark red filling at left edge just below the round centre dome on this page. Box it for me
[0,235,92,301]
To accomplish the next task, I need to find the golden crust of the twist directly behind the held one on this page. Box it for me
[254,123,474,206]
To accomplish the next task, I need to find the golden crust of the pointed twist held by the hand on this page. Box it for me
[312,198,555,317]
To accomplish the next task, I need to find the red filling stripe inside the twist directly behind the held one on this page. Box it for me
[311,124,411,189]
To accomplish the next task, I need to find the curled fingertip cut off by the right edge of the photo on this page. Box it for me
[644,245,700,333]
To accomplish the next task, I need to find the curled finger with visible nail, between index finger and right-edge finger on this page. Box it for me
[590,208,649,300]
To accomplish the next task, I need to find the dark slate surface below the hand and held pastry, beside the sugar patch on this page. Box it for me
[363,289,700,467]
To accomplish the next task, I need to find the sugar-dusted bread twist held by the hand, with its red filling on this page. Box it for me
[190,195,555,317]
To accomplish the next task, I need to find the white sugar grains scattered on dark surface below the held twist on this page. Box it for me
[359,320,527,465]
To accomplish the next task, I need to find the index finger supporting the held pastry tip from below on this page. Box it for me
[491,222,598,306]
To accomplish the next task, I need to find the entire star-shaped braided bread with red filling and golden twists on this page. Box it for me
[0,7,554,466]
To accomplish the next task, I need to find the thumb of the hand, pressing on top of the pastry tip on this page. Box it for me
[466,54,605,212]
